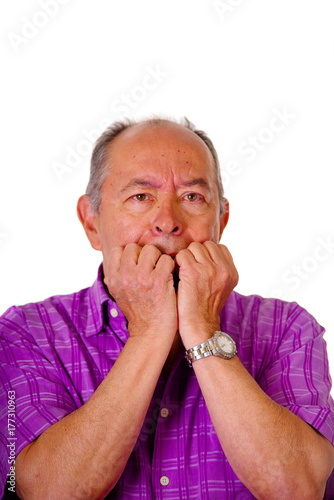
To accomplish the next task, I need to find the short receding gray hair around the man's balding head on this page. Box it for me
[86,117,225,215]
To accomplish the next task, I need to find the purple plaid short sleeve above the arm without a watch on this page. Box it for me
[0,307,76,498]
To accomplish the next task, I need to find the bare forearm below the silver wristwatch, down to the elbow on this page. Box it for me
[193,356,333,500]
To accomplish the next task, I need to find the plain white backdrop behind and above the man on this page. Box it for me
[0,0,334,373]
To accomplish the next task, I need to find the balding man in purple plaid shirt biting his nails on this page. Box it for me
[0,120,334,500]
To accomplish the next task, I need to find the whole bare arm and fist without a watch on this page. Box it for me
[16,245,177,499]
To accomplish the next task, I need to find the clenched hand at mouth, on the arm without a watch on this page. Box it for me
[103,243,177,341]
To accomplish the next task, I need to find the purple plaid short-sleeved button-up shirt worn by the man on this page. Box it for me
[0,267,334,500]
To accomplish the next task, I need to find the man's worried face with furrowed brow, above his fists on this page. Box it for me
[80,123,228,259]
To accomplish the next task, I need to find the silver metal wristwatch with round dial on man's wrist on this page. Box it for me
[185,332,237,366]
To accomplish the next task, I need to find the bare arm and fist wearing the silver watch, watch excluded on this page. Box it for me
[177,242,334,500]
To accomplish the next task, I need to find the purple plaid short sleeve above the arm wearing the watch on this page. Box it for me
[258,303,334,444]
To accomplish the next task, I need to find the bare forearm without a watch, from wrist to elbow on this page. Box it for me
[17,337,170,499]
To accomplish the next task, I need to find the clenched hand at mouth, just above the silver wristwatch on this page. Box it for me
[175,241,239,349]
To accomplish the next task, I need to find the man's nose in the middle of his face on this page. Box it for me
[152,202,183,236]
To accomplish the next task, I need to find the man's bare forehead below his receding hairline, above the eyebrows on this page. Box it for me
[108,122,215,177]
